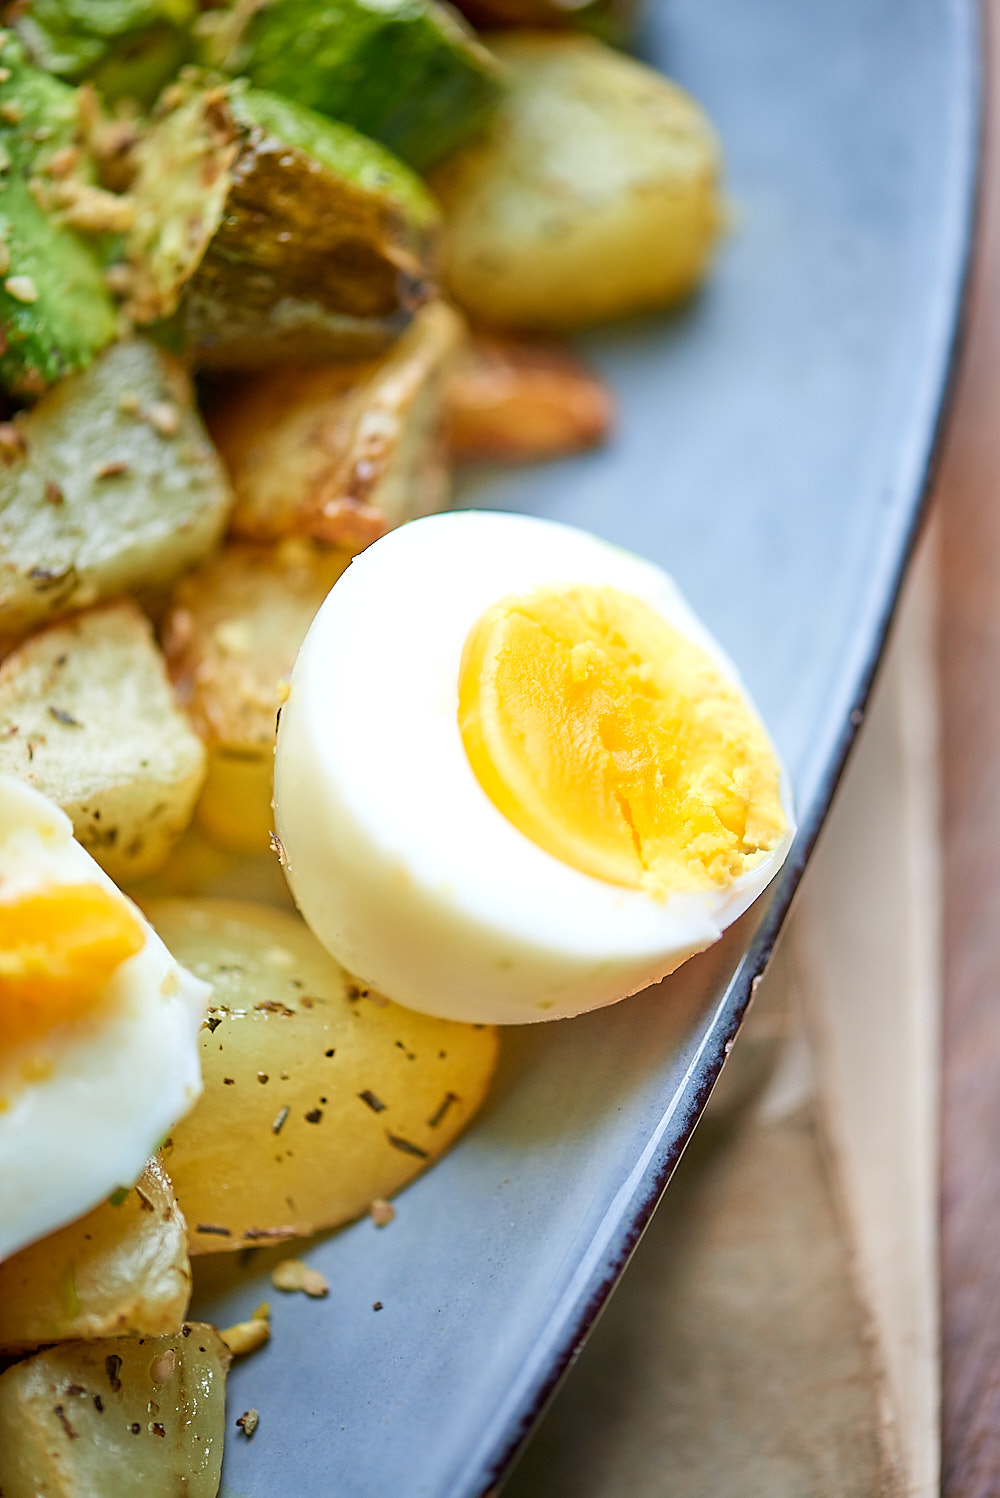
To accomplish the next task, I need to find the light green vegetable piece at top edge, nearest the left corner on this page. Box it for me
[15,0,198,103]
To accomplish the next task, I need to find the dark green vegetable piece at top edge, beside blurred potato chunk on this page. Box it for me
[205,0,500,171]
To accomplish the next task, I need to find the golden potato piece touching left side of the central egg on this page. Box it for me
[163,539,349,852]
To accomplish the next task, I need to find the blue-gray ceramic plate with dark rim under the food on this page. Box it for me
[199,0,978,1498]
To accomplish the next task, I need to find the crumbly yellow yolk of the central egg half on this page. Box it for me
[458,586,787,899]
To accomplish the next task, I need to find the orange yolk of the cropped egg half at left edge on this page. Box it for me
[0,884,145,1049]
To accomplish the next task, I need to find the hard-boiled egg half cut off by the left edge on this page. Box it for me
[0,776,211,1258]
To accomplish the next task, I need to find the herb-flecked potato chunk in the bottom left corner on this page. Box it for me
[0,1323,229,1498]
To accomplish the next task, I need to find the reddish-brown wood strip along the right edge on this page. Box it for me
[937,0,1000,1498]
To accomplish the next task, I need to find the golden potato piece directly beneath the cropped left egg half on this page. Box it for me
[0,1159,192,1353]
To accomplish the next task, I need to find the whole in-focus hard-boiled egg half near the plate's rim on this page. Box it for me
[274,511,793,1023]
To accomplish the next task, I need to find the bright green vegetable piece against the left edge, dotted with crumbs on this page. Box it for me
[0,31,118,395]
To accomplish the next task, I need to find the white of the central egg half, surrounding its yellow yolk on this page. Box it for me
[274,511,793,1023]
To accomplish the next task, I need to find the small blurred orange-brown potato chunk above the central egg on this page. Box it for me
[445,334,614,463]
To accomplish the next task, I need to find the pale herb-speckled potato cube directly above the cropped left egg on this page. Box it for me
[0,604,205,881]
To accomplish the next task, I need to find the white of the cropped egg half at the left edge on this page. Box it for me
[0,776,211,1258]
